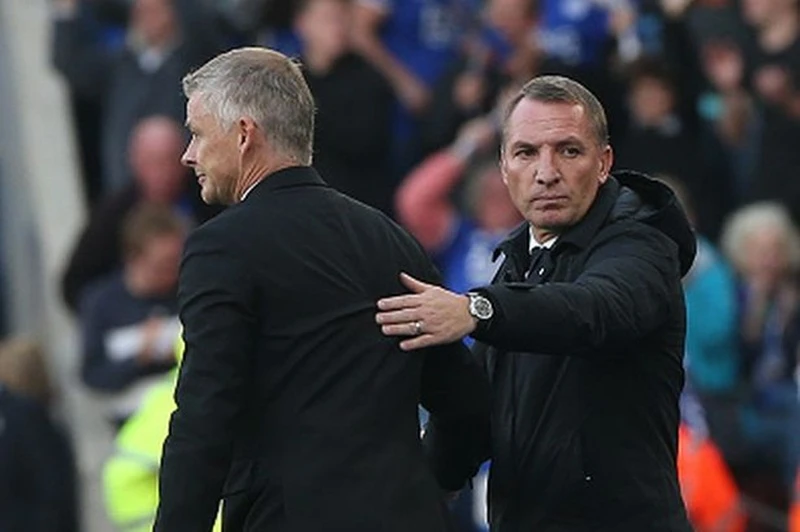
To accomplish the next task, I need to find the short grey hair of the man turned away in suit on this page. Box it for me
[183,47,314,164]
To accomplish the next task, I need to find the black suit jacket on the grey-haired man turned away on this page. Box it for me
[155,167,488,532]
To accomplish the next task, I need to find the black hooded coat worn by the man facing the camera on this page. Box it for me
[428,173,695,532]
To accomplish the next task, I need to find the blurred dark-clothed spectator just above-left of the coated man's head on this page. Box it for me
[420,0,536,156]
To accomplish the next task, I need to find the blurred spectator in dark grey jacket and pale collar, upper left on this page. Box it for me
[53,0,223,193]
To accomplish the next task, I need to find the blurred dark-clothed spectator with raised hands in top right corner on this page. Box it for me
[703,0,800,220]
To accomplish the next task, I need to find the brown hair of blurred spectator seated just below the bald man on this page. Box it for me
[122,203,188,258]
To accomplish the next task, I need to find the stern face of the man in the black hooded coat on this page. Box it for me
[501,99,613,239]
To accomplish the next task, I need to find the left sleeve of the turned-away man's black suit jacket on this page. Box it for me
[154,225,256,532]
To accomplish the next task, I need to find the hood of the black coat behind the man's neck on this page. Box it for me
[609,171,697,275]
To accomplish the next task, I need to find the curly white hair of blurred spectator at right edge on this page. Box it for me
[720,201,800,272]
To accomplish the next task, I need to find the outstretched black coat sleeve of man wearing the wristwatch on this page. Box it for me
[472,224,683,355]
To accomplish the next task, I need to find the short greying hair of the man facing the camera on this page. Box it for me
[503,75,609,146]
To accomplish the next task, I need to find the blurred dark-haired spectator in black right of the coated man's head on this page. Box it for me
[615,58,731,239]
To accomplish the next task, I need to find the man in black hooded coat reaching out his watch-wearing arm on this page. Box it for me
[376,76,696,532]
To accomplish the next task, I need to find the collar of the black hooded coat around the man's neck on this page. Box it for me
[492,177,620,260]
